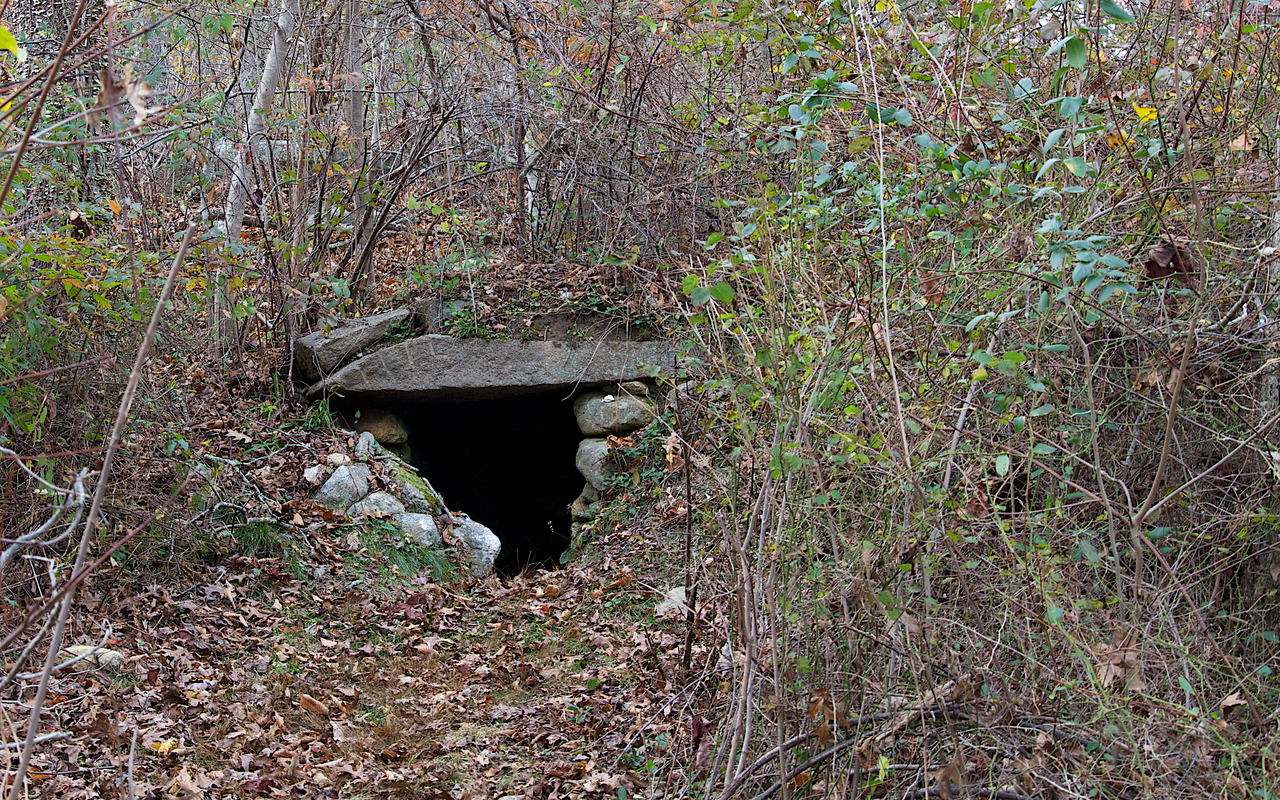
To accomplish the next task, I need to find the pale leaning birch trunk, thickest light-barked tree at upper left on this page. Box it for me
[217,0,302,357]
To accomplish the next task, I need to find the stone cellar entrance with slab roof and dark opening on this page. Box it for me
[307,335,678,575]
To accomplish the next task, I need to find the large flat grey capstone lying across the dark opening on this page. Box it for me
[307,335,676,402]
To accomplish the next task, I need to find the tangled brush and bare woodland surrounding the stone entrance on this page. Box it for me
[0,0,1280,799]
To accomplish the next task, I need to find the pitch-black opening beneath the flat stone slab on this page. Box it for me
[397,390,584,576]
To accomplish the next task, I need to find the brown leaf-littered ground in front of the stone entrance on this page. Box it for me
[27,501,714,799]
